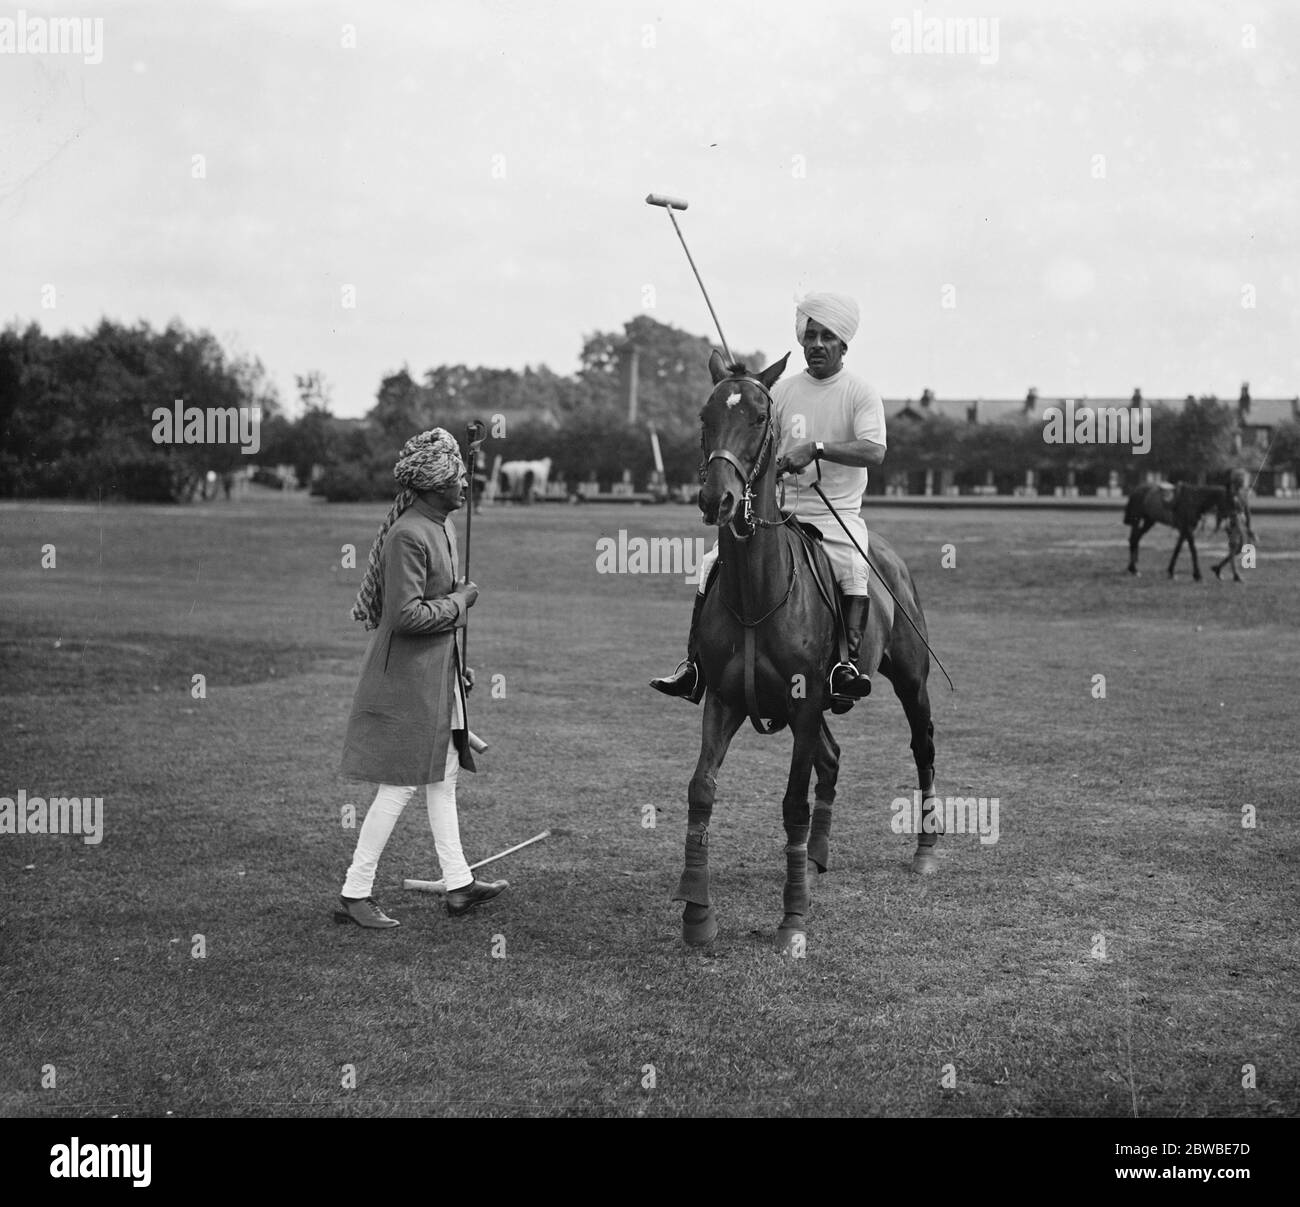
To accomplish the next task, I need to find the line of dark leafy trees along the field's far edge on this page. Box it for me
[0,315,1300,501]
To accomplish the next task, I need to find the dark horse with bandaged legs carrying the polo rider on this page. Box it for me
[673,351,943,956]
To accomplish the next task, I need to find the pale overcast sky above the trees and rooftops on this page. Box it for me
[0,0,1300,415]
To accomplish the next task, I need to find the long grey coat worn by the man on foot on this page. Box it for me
[341,498,475,784]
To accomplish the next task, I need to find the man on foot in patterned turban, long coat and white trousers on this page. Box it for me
[334,428,507,930]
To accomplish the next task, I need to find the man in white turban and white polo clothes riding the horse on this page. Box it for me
[650,293,885,704]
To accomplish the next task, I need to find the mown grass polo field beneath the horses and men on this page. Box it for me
[0,499,1300,1117]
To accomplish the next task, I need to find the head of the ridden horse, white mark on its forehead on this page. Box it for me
[699,351,790,527]
